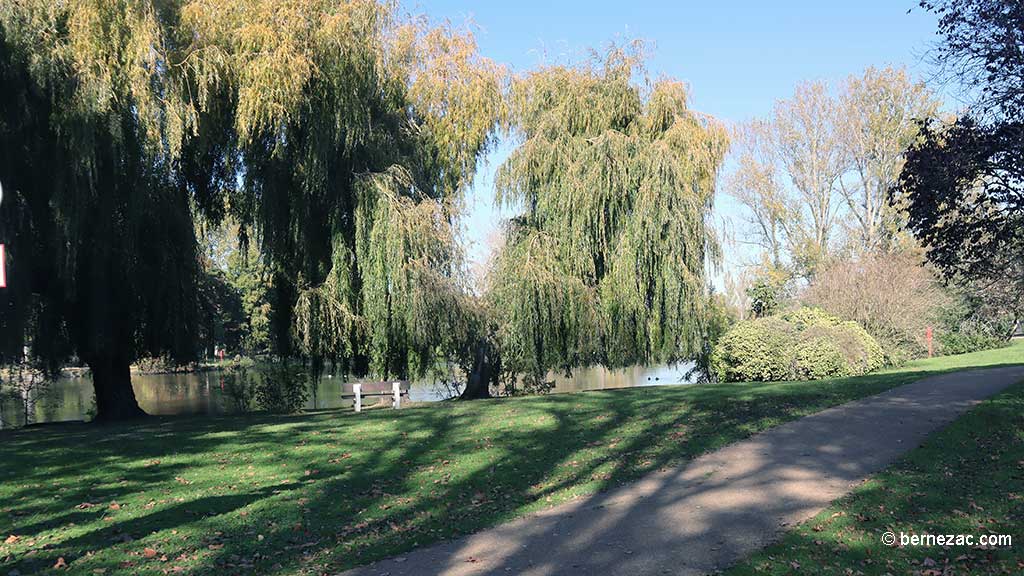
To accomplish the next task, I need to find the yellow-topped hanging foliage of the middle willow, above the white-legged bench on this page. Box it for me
[181,0,504,376]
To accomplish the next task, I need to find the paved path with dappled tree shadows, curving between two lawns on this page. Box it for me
[345,367,1024,576]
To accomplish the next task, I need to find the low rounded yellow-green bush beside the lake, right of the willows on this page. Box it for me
[712,307,886,381]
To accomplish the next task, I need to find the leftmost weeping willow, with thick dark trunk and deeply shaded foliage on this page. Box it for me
[0,0,203,419]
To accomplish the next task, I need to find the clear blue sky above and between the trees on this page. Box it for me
[403,0,936,280]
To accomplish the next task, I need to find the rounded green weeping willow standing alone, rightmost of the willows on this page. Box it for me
[466,45,728,397]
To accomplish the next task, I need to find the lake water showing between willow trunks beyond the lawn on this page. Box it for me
[0,364,692,428]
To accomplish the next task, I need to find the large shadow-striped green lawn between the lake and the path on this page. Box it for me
[6,342,1024,575]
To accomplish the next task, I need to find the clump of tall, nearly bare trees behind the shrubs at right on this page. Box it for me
[725,68,939,280]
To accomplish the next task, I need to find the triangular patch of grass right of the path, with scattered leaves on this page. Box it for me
[726,366,1024,576]
